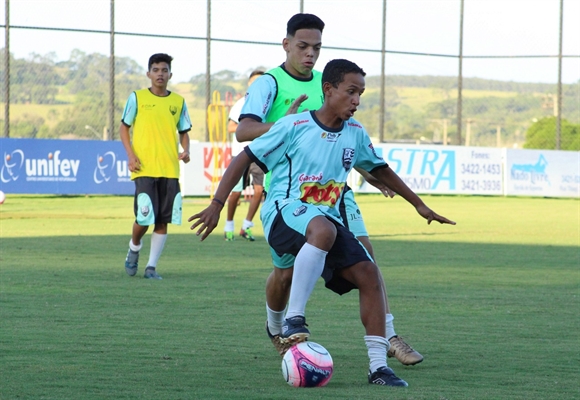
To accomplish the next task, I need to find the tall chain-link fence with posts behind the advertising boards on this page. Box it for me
[0,0,580,150]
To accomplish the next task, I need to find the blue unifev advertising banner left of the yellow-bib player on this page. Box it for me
[0,139,135,194]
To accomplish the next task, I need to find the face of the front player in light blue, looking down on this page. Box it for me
[325,72,365,121]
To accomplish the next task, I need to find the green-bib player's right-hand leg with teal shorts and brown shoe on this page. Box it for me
[343,190,423,365]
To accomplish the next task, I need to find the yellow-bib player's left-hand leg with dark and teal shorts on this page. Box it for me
[125,177,155,276]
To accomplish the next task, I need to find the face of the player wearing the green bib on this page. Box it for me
[282,29,322,78]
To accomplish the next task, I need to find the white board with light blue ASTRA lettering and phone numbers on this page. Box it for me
[359,144,503,195]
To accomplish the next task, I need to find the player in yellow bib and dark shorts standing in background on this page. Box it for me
[120,54,191,279]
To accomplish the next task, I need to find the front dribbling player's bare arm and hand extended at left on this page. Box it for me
[187,151,252,241]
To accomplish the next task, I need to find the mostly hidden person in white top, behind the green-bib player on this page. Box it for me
[224,70,264,242]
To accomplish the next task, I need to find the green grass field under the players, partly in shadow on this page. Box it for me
[0,195,580,400]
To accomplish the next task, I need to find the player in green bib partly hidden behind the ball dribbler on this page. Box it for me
[236,14,423,365]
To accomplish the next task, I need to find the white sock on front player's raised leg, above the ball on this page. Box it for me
[286,243,328,318]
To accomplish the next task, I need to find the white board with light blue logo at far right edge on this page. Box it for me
[504,149,580,197]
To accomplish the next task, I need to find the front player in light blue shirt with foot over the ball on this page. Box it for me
[188,60,455,386]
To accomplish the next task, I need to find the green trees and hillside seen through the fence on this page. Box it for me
[0,49,580,150]
